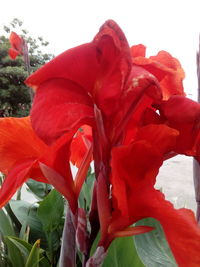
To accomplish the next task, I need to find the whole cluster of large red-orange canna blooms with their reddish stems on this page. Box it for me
[0,20,200,267]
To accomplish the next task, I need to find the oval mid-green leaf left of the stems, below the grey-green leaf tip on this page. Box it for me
[38,189,64,232]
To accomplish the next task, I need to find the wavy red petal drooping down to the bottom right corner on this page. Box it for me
[109,138,200,267]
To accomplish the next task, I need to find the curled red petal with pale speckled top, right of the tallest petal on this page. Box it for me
[111,66,162,146]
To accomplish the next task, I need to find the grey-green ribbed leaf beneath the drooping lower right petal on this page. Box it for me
[134,218,178,267]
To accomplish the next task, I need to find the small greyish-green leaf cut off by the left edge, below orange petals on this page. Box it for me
[0,209,15,236]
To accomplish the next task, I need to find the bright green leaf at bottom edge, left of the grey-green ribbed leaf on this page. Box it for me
[103,236,144,267]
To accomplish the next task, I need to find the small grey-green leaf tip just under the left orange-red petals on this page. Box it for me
[26,179,52,200]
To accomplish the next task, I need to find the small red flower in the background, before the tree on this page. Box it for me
[9,32,25,59]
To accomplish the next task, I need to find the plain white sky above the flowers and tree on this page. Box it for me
[0,0,200,97]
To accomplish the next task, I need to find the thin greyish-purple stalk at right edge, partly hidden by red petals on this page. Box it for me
[193,36,200,223]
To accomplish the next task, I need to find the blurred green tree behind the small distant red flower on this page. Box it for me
[0,18,53,117]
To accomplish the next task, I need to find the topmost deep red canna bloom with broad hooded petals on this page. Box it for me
[26,21,162,149]
